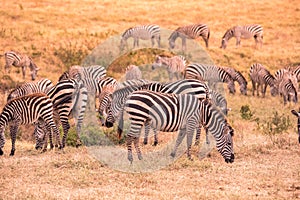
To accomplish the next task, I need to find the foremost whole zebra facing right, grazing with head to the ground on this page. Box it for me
[124,90,234,163]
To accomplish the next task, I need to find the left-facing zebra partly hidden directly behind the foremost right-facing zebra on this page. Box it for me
[105,79,210,145]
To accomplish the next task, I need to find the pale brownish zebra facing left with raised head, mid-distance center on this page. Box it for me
[152,55,186,81]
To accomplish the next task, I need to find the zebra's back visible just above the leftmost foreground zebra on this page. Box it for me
[7,78,53,101]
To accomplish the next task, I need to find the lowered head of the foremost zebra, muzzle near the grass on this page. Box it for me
[217,122,234,163]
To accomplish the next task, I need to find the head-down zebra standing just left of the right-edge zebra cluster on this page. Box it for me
[250,63,278,97]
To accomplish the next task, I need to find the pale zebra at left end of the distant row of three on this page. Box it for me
[120,24,160,50]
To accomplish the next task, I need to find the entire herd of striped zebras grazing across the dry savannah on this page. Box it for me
[0,24,300,163]
